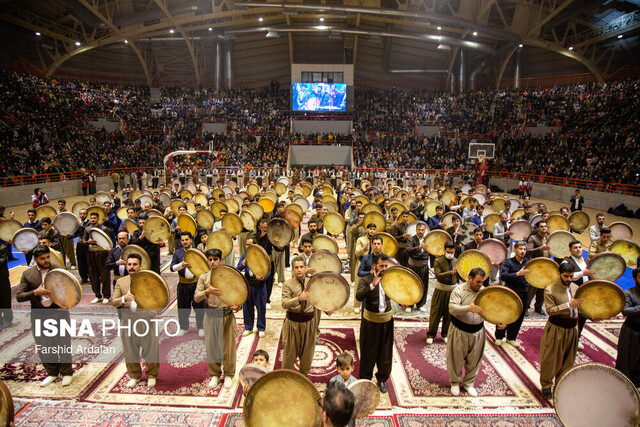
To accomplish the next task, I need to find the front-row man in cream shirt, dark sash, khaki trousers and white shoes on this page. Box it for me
[447,268,506,397]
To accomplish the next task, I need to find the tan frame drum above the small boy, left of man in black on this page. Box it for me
[306,271,351,311]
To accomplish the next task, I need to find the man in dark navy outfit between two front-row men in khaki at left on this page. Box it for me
[171,231,204,337]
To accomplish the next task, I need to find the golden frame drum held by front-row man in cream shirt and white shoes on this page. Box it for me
[475,285,522,325]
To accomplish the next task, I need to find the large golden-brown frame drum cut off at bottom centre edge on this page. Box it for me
[242,369,322,427]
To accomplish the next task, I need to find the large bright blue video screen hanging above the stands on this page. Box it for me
[291,83,347,111]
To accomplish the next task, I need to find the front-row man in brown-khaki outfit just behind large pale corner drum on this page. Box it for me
[540,262,584,399]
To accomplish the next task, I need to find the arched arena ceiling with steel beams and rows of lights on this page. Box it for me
[0,0,640,89]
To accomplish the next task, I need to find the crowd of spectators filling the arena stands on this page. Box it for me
[0,72,640,183]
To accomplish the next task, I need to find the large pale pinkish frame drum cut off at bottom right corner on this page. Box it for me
[553,363,640,427]
